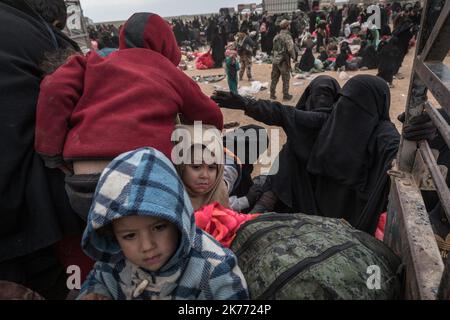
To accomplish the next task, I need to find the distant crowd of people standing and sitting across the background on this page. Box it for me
[162,1,422,100]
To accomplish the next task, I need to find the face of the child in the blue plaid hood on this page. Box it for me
[113,216,179,271]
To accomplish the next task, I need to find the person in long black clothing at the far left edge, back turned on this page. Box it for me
[0,0,84,298]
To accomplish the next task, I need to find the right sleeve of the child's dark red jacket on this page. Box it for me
[181,74,223,130]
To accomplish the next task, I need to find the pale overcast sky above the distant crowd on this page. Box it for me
[80,0,262,22]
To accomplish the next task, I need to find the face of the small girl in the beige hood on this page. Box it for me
[181,163,217,194]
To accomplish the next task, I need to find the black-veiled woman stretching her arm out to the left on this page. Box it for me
[212,76,340,214]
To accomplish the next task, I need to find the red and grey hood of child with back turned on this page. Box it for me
[119,13,181,66]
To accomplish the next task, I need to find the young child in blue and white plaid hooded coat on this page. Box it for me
[78,148,249,300]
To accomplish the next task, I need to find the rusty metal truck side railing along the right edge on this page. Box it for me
[384,0,450,300]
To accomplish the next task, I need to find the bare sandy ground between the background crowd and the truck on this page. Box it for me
[182,48,449,175]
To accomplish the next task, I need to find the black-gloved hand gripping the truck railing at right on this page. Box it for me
[398,112,436,141]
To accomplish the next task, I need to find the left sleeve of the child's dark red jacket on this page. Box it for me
[35,55,86,156]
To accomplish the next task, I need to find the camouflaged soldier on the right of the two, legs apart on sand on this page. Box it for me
[270,20,295,100]
